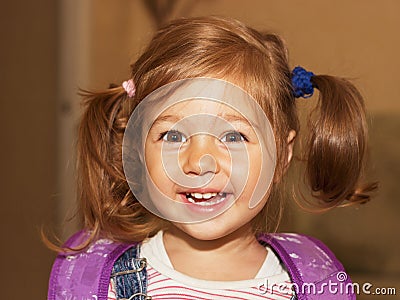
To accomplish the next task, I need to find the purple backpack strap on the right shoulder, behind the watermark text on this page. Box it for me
[258,233,356,300]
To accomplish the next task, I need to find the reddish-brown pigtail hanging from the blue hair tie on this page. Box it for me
[306,75,376,208]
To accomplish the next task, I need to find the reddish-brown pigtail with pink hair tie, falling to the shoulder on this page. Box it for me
[77,81,159,248]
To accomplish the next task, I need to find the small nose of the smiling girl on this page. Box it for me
[180,134,222,175]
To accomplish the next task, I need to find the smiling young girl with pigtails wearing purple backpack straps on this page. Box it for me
[48,17,371,299]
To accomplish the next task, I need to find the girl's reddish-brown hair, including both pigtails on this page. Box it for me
[61,17,376,247]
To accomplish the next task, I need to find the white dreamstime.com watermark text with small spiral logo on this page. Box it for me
[258,272,400,296]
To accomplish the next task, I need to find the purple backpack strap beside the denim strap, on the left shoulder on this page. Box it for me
[47,231,133,300]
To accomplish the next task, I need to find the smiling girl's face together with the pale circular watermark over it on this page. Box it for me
[122,77,276,239]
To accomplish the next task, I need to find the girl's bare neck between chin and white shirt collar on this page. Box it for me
[164,226,267,281]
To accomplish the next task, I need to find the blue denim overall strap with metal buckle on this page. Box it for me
[111,245,151,300]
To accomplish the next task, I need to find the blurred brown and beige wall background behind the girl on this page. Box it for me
[0,0,400,299]
